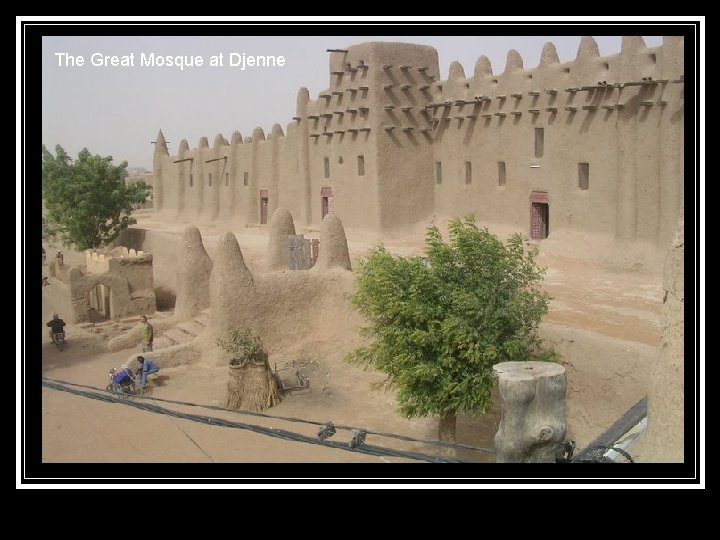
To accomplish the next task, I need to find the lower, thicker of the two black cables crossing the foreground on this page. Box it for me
[42,377,473,463]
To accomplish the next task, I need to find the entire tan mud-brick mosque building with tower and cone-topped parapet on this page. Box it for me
[153,36,684,255]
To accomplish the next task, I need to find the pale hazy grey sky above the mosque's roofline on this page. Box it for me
[42,34,662,169]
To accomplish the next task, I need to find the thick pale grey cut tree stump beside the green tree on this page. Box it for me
[493,361,565,463]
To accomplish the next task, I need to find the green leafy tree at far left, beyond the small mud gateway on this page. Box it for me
[42,145,152,251]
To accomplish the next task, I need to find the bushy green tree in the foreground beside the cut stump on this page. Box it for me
[346,217,555,441]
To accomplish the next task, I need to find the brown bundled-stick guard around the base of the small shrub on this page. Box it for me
[226,360,282,411]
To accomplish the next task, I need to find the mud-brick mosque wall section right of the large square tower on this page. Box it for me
[431,37,684,250]
